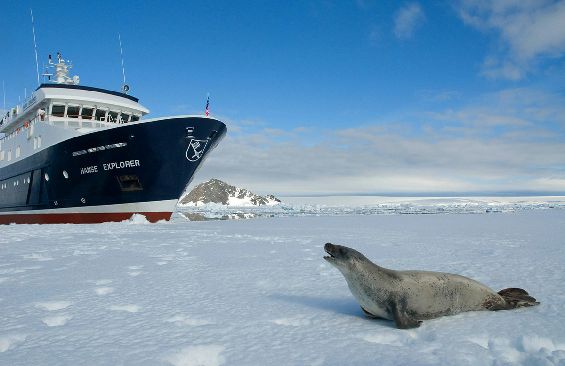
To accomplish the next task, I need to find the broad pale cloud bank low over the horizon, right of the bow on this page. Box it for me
[195,89,565,194]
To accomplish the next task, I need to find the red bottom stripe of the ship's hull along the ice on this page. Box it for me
[0,212,173,224]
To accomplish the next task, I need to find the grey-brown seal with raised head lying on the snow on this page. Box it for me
[324,243,539,329]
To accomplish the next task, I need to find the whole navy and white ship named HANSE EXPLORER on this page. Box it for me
[0,53,226,224]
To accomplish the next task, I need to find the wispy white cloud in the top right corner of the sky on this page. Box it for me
[456,0,565,80]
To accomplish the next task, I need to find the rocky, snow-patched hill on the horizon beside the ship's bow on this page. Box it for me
[179,179,281,207]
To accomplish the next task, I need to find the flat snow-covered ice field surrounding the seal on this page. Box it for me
[0,198,565,366]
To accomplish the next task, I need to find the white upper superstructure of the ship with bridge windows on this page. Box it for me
[0,53,149,168]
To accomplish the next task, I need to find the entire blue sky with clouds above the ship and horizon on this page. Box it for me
[0,0,565,195]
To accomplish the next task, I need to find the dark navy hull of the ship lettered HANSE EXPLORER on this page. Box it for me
[0,117,226,224]
